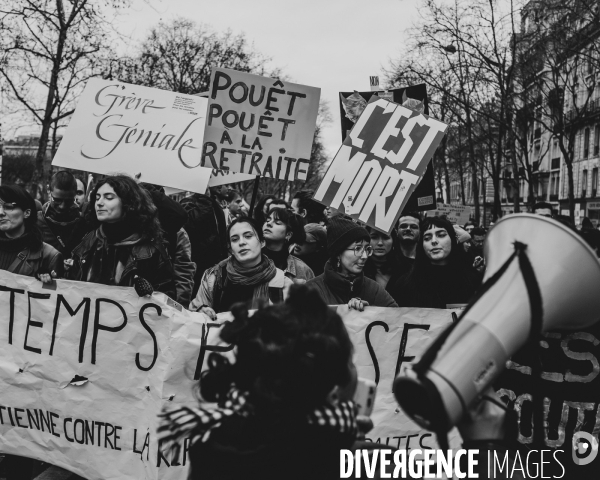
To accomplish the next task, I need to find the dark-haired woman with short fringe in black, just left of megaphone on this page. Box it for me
[390,217,481,308]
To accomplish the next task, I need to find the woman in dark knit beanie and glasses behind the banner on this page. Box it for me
[307,215,397,311]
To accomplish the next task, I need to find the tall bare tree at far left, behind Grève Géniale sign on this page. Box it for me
[0,0,122,197]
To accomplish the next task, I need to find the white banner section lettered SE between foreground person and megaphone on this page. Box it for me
[337,305,460,450]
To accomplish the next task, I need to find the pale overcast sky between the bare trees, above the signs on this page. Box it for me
[117,0,417,156]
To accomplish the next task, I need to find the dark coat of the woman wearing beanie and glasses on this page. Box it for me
[306,262,398,307]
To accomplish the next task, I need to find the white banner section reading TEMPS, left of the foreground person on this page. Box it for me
[0,271,210,480]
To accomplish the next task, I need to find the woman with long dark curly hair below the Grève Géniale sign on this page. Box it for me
[67,175,176,299]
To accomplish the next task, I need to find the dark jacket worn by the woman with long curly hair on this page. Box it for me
[66,228,177,300]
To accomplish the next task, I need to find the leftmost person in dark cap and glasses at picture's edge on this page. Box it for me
[0,185,63,283]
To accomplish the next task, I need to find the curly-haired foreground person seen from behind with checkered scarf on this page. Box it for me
[158,285,358,480]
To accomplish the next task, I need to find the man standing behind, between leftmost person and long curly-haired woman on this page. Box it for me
[37,170,88,259]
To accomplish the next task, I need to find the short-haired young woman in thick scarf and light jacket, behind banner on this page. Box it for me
[190,217,292,319]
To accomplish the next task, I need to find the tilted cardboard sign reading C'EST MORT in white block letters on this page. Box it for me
[314,97,448,234]
